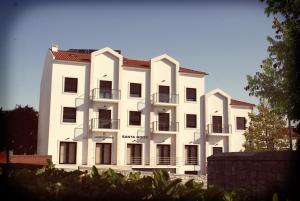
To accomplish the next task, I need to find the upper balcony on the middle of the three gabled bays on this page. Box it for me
[151,93,179,106]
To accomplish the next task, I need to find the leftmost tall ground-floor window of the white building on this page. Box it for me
[59,142,76,164]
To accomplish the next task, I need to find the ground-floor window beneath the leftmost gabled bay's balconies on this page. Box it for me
[95,143,111,164]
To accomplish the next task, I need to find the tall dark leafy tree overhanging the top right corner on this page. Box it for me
[246,0,300,132]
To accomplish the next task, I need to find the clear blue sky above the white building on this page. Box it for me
[0,0,274,110]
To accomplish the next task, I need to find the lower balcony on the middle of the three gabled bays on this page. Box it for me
[152,121,179,134]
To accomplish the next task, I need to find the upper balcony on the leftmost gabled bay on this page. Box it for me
[91,88,121,102]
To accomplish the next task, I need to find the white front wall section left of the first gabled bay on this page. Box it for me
[48,61,89,164]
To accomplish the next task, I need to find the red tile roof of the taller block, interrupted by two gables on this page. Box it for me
[52,50,208,75]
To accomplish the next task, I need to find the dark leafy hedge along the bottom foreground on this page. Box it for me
[1,166,258,201]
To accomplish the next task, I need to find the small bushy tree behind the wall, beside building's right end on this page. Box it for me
[244,103,289,151]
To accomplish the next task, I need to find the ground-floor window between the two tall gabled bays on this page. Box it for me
[127,144,142,165]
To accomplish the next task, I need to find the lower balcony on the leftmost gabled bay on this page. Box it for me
[91,118,120,132]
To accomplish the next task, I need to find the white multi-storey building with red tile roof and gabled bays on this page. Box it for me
[38,45,254,174]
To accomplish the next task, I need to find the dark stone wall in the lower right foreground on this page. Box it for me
[207,151,300,200]
